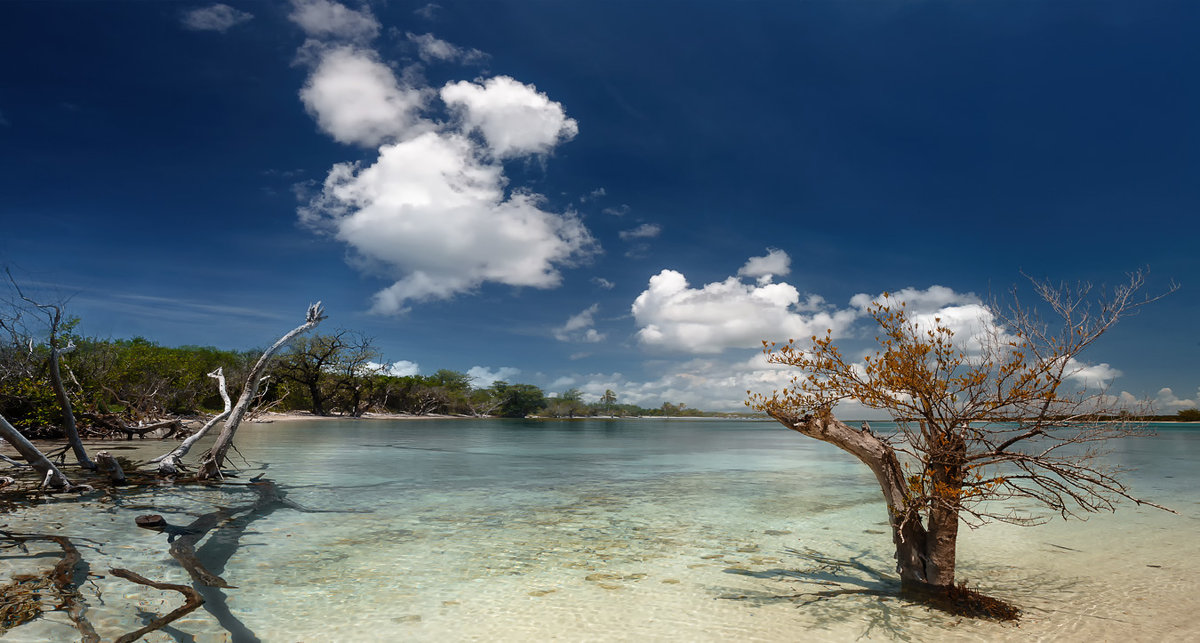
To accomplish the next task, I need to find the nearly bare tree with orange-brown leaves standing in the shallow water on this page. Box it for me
[749,272,1163,597]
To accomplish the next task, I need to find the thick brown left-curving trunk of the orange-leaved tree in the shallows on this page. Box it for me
[768,409,958,589]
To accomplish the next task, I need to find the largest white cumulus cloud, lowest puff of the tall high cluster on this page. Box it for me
[301,132,593,313]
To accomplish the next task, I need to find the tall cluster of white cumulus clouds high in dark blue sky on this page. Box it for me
[293,9,596,313]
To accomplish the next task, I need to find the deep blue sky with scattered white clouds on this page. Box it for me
[0,0,1200,413]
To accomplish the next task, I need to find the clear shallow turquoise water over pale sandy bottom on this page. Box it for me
[0,420,1200,642]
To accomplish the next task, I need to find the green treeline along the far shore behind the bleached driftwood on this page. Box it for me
[0,327,715,438]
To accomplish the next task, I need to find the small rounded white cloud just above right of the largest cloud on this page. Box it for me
[442,76,578,158]
